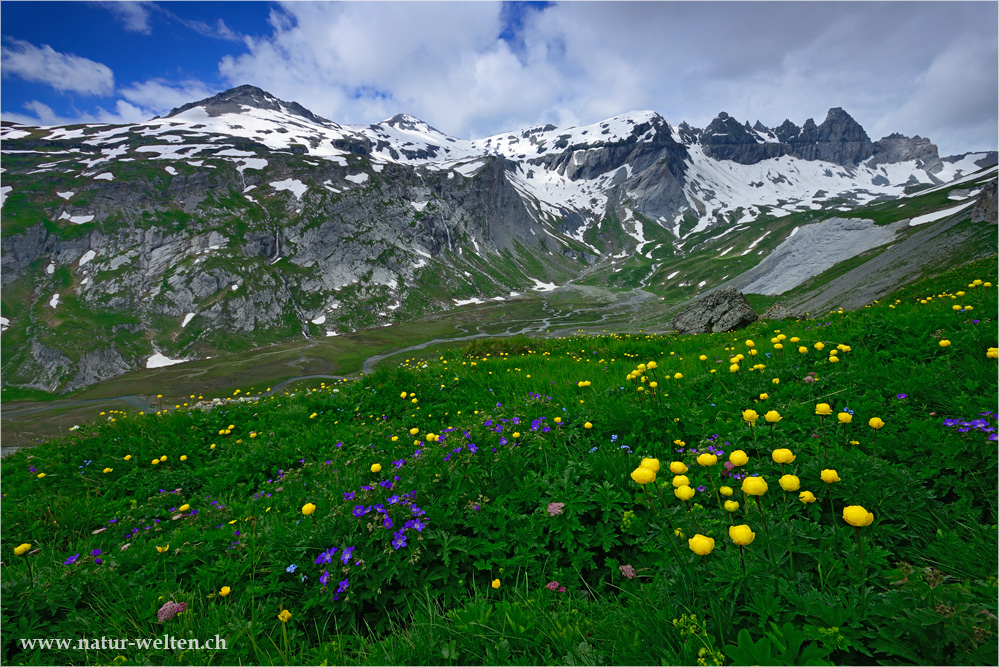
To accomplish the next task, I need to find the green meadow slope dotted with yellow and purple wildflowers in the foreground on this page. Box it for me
[0,257,999,665]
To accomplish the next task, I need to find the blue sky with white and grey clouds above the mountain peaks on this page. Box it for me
[0,0,999,155]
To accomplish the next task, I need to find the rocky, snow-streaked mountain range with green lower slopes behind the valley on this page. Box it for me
[0,86,996,391]
